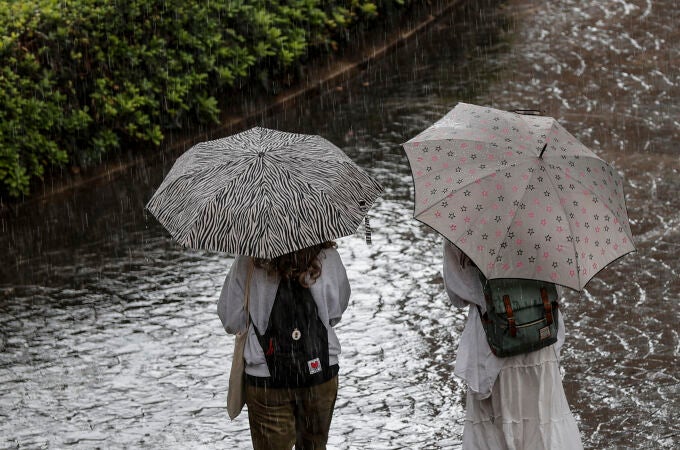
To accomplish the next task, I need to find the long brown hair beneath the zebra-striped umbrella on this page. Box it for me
[253,241,337,287]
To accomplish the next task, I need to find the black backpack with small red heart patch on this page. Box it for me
[254,279,334,388]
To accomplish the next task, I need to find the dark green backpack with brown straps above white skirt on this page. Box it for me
[477,276,559,357]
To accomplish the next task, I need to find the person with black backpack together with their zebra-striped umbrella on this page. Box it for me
[146,127,383,450]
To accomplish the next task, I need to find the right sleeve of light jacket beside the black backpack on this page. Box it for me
[312,249,352,327]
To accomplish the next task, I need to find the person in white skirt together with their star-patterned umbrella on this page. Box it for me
[403,103,635,450]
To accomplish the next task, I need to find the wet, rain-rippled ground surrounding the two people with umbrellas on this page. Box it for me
[0,0,680,449]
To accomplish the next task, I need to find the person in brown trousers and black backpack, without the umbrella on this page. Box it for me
[218,242,350,450]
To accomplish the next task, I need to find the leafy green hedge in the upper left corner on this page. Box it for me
[0,0,411,198]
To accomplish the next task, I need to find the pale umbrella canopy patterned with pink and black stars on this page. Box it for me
[403,103,635,290]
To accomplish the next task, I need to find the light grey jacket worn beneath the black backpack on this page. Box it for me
[217,248,351,377]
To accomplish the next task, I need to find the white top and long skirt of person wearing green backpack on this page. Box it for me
[443,240,583,450]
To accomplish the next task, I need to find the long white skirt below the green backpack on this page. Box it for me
[463,345,583,450]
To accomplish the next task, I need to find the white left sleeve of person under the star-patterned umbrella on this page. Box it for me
[442,240,484,308]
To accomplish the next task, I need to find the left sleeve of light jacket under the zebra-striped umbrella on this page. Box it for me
[217,256,249,334]
